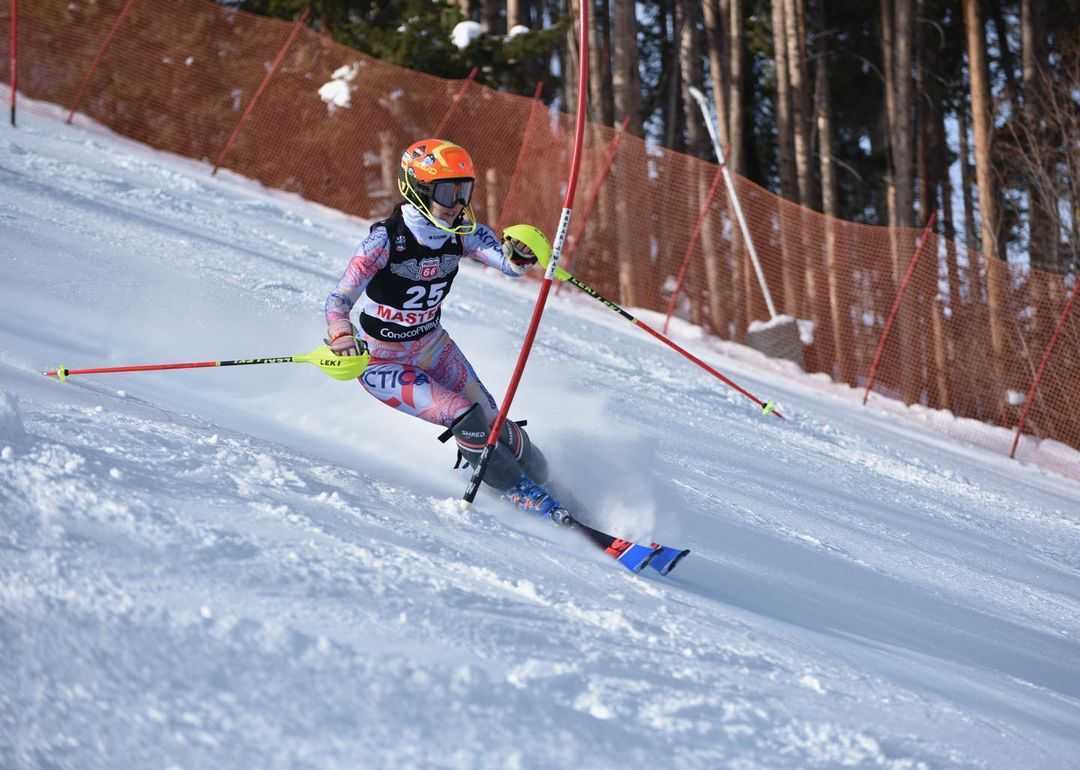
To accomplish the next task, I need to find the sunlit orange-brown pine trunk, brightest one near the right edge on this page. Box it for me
[963,0,1008,375]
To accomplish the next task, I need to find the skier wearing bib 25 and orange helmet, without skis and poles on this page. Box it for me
[325,139,570,524]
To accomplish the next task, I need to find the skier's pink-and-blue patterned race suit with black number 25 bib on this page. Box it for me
[325,203,518,427]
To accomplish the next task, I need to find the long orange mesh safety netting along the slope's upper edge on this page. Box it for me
[0,0,1080,448]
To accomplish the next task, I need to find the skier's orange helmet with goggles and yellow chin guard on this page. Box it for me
[397,139,476,234]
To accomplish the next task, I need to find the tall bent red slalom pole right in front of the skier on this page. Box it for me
[463,2,589,503]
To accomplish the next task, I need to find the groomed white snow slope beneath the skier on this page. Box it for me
[0,108,1080,770]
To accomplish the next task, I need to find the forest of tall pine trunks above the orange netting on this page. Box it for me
[236,0,1080,278]
